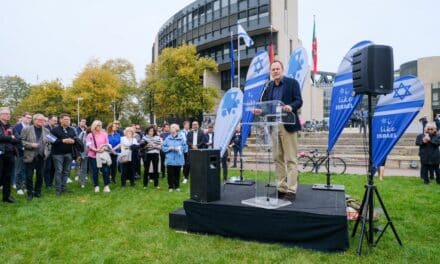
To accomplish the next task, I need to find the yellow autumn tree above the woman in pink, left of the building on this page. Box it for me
[65,62,121,122]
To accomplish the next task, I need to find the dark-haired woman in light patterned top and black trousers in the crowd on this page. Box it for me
[142,126,162,189]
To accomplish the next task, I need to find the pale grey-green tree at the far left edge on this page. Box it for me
[0,76,30,111]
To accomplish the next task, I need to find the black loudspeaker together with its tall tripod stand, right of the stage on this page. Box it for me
[352,45,402,255]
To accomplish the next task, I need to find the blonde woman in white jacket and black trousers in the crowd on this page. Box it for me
[119,127,138,187]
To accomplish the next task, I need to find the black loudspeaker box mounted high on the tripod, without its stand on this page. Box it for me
[352,45,394,95]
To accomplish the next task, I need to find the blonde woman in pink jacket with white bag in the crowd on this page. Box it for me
[87,120,111,192]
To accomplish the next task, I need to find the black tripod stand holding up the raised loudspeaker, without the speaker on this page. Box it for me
[351,94,402,256]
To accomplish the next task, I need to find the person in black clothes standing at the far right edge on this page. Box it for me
[416,123,440,184]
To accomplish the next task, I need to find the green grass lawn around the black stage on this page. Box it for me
[0,170,440,263]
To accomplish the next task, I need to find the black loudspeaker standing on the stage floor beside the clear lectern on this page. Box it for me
[189,149,220,202]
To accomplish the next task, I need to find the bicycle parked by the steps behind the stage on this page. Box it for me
[298,149,347,174]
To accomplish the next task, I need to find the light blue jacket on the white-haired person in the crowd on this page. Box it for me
[162,134,188,166]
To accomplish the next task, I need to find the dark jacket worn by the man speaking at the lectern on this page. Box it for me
[260,76,303,132]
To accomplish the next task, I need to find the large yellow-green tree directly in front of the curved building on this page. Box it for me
[142,45,218,118]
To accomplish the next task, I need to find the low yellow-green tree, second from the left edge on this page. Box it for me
[14,80,67,116]
